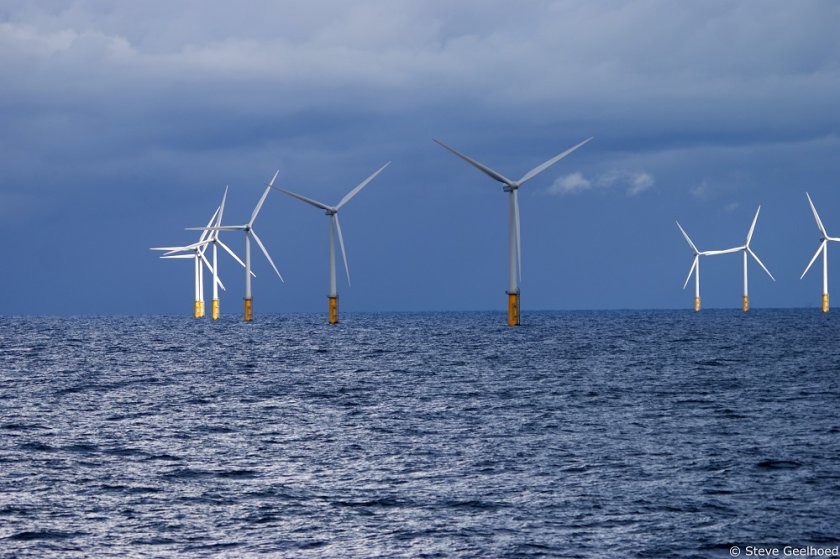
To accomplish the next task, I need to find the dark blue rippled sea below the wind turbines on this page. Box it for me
[0,309,840,558]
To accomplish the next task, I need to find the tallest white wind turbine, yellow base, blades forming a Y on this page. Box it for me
[435,138,592,326]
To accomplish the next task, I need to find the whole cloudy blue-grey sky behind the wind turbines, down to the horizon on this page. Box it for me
[0,0,840,316]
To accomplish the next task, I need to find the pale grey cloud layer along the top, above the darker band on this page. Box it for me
[0,1,840,122]
